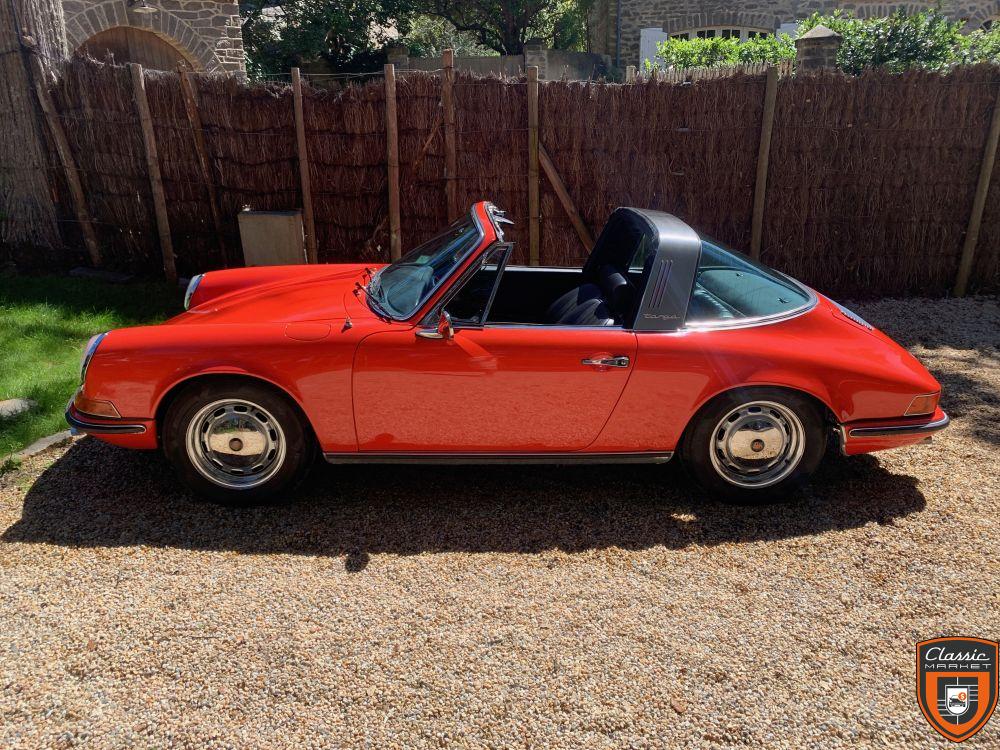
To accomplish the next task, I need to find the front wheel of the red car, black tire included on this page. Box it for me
[161,377,316,506]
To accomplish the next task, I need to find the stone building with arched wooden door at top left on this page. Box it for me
[63,0,246,75]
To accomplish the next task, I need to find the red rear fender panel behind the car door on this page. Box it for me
[592,298,941,451]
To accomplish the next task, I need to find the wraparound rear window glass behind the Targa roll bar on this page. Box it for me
[687,240,810,325]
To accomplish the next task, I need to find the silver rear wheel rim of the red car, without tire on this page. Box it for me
[709,401,806,489]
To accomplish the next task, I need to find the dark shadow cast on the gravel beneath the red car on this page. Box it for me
[0,439,925,571]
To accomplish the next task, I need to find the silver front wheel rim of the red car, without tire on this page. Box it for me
[186,399,286,490]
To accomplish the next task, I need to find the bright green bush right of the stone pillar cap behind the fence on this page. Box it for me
[799,10,969,75]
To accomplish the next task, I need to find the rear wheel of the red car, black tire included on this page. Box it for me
[680,387,827,503]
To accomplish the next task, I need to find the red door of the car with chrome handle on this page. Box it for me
[353,325,636,453]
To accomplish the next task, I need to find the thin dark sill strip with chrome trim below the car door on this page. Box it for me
[323,451,674,466]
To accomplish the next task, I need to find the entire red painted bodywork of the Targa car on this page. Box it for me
[83,205,940,453]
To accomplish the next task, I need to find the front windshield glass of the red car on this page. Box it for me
[368,216,482,320]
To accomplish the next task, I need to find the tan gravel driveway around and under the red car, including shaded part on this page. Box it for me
[0,297,1000,750]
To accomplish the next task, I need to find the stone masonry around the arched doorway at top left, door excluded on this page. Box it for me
[63,0,246,74]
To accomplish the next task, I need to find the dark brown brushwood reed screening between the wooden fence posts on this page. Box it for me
[7,60,1000,297]
